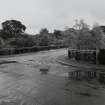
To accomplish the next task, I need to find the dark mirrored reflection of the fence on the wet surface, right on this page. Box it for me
[68,70,105,84]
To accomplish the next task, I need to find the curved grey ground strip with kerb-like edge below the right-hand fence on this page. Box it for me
[56,54,105,71]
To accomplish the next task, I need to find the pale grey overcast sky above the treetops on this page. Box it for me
[0,0,105,34]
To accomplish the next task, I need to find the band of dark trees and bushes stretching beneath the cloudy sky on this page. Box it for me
[0,20,105,55]
